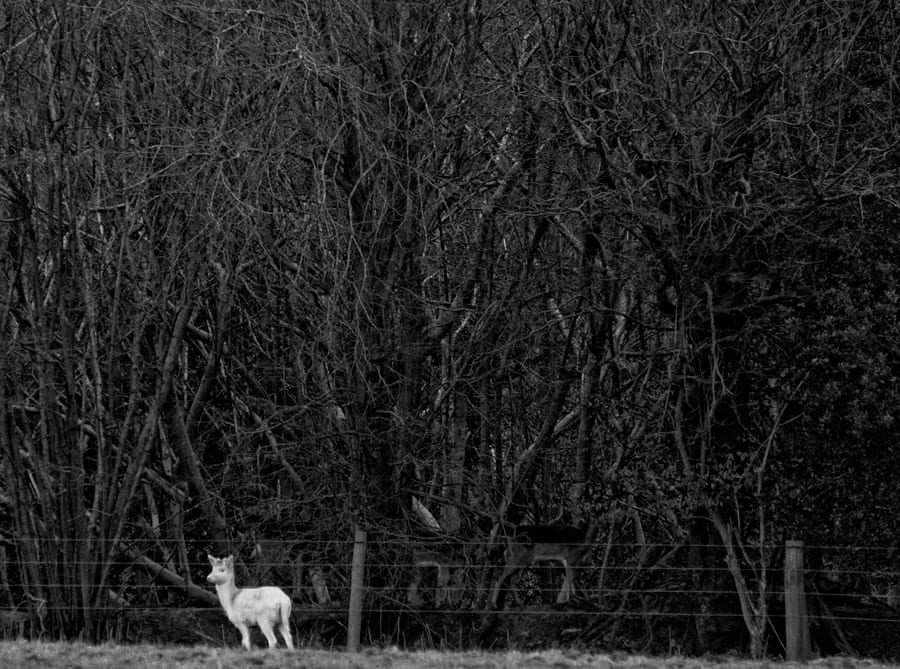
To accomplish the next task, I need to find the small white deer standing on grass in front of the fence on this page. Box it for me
[206,555,294,650]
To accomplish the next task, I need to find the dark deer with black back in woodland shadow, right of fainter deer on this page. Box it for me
[491,519,598,606]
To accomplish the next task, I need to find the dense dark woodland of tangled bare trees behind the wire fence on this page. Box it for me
[0,0,900,654]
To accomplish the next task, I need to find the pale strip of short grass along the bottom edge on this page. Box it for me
[0,641,890,669]
